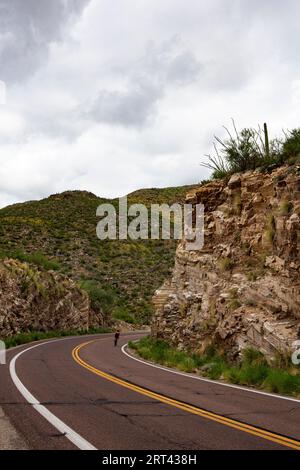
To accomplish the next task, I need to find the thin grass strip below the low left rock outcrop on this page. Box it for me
[3,328,112,349]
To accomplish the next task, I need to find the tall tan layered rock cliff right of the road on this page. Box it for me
[152,166,300,357]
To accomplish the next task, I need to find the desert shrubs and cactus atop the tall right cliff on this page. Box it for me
[201,120,300,179]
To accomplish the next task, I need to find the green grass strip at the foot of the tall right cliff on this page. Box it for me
[129,336,300,397]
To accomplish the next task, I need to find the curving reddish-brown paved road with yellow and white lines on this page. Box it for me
[0,333,300,450]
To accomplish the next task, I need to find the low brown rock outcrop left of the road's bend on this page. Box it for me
[0,260,102,339]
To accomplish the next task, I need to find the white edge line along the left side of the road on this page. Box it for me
[9,338,97,450]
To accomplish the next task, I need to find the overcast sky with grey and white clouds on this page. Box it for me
[0,0,300,206]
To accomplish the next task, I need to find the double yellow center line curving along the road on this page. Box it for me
[72,340,300,450]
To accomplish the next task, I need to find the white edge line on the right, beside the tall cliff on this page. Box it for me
[121,340,300,403]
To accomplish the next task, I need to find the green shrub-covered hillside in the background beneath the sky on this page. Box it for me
[0,186,199,323]
